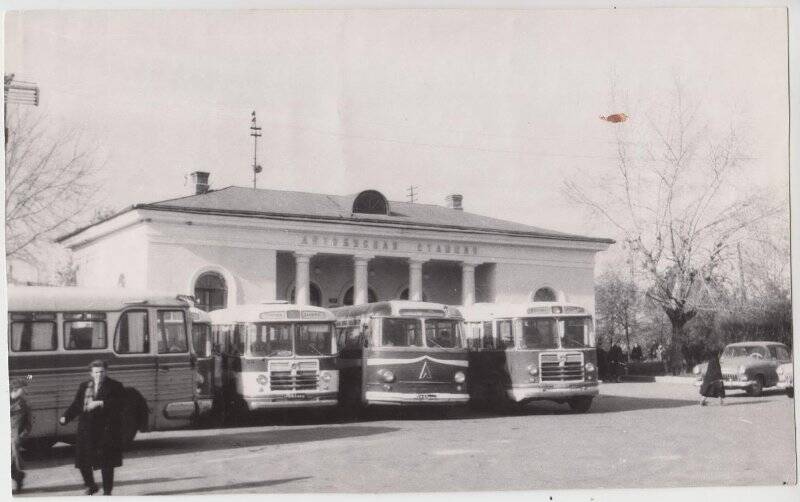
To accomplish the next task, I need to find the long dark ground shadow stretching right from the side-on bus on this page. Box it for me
[25,425,399,467]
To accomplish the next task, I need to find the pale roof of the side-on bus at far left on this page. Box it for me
[8,286,188,312]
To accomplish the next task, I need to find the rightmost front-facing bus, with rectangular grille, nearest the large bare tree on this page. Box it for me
[462,302,598,413]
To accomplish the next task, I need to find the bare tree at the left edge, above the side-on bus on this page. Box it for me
[5,109,98,262]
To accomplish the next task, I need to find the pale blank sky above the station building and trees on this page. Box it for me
[5,9,788,245]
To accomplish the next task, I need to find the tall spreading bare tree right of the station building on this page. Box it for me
[565,81,780,370]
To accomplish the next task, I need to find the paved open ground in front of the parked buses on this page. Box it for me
[15,383,796,496]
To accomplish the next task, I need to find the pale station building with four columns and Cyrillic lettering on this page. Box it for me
[58,173,613,309]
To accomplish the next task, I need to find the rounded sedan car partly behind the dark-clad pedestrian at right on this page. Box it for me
[694,342,792,396]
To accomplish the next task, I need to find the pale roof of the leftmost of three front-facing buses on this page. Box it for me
[208,302,336,324]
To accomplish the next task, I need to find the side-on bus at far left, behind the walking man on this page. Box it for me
[8,286,202,446]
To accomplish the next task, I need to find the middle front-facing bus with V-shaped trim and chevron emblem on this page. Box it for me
[332,300,469,407]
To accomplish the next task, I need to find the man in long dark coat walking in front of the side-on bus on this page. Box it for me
[59,360,125,495]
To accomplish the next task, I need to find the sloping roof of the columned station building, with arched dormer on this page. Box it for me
[57,186,614,244]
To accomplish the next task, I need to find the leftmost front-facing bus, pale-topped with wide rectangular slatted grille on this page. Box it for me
[209,302,339,414]
